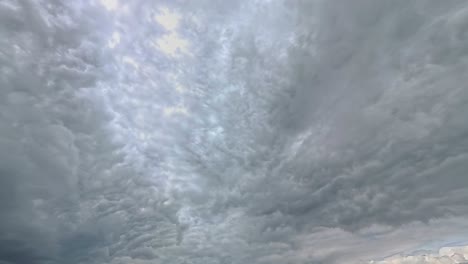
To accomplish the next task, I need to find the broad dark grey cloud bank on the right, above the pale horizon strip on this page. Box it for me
[272,1,468,227]
